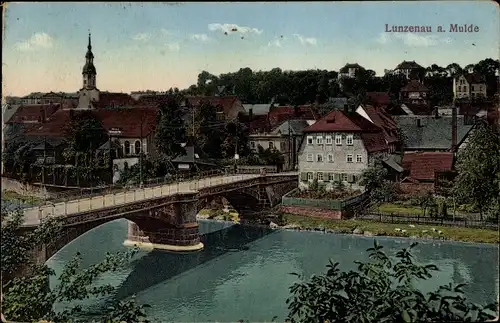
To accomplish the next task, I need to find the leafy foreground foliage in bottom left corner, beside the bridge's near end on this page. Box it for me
[1,208,151,322]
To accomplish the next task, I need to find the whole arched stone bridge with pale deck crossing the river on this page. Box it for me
[18,172,298,270]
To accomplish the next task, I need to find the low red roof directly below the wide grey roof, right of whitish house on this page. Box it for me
[403,152,453,180]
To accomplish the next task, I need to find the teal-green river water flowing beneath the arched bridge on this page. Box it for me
[47,220,499,322]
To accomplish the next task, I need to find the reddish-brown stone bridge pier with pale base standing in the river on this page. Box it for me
[123,194,204,252]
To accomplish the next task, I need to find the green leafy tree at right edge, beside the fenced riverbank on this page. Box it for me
[453,122,500,218]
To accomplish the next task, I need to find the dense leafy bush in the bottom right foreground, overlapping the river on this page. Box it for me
[287,240,497,323]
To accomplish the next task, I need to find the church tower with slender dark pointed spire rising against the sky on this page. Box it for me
[78,33,99,110]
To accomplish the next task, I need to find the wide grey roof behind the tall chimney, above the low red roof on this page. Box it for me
[394,116,472,150]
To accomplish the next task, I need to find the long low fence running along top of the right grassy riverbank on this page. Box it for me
[360,212,499,230]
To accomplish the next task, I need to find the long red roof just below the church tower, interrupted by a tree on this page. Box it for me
[26,108,158,138]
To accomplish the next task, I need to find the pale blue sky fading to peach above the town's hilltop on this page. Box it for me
[2,1,500,96]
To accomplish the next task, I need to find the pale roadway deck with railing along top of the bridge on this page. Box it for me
[23,172,297,226]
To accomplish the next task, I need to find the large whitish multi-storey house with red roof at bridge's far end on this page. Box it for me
[298,107,389,189]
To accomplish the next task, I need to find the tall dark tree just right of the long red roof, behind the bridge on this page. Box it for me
[155,94,185,161]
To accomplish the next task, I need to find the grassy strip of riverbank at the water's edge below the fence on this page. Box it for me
[284,214,500,244]
